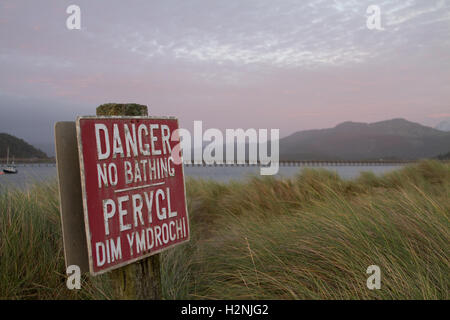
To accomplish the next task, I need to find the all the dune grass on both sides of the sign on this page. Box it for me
[0,161,450,299]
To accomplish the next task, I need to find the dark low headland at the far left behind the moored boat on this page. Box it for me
[0,133,47,159]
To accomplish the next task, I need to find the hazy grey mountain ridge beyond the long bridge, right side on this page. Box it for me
[280,119,450,160]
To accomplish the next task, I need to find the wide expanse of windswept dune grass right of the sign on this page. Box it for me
[163,161,450,299]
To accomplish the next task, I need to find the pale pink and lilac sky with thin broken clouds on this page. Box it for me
[0,0,450,154]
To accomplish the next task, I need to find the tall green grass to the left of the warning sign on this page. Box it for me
[0,182,107,299]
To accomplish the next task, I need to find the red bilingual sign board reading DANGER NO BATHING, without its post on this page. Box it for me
[77,117,189,275]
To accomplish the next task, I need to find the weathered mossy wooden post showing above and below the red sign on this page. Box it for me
[96,103,162,300]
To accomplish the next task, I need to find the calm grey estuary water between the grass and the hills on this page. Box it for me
[0,165,402,191]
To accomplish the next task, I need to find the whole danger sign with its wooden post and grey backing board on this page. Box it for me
[55,104,189,299]
